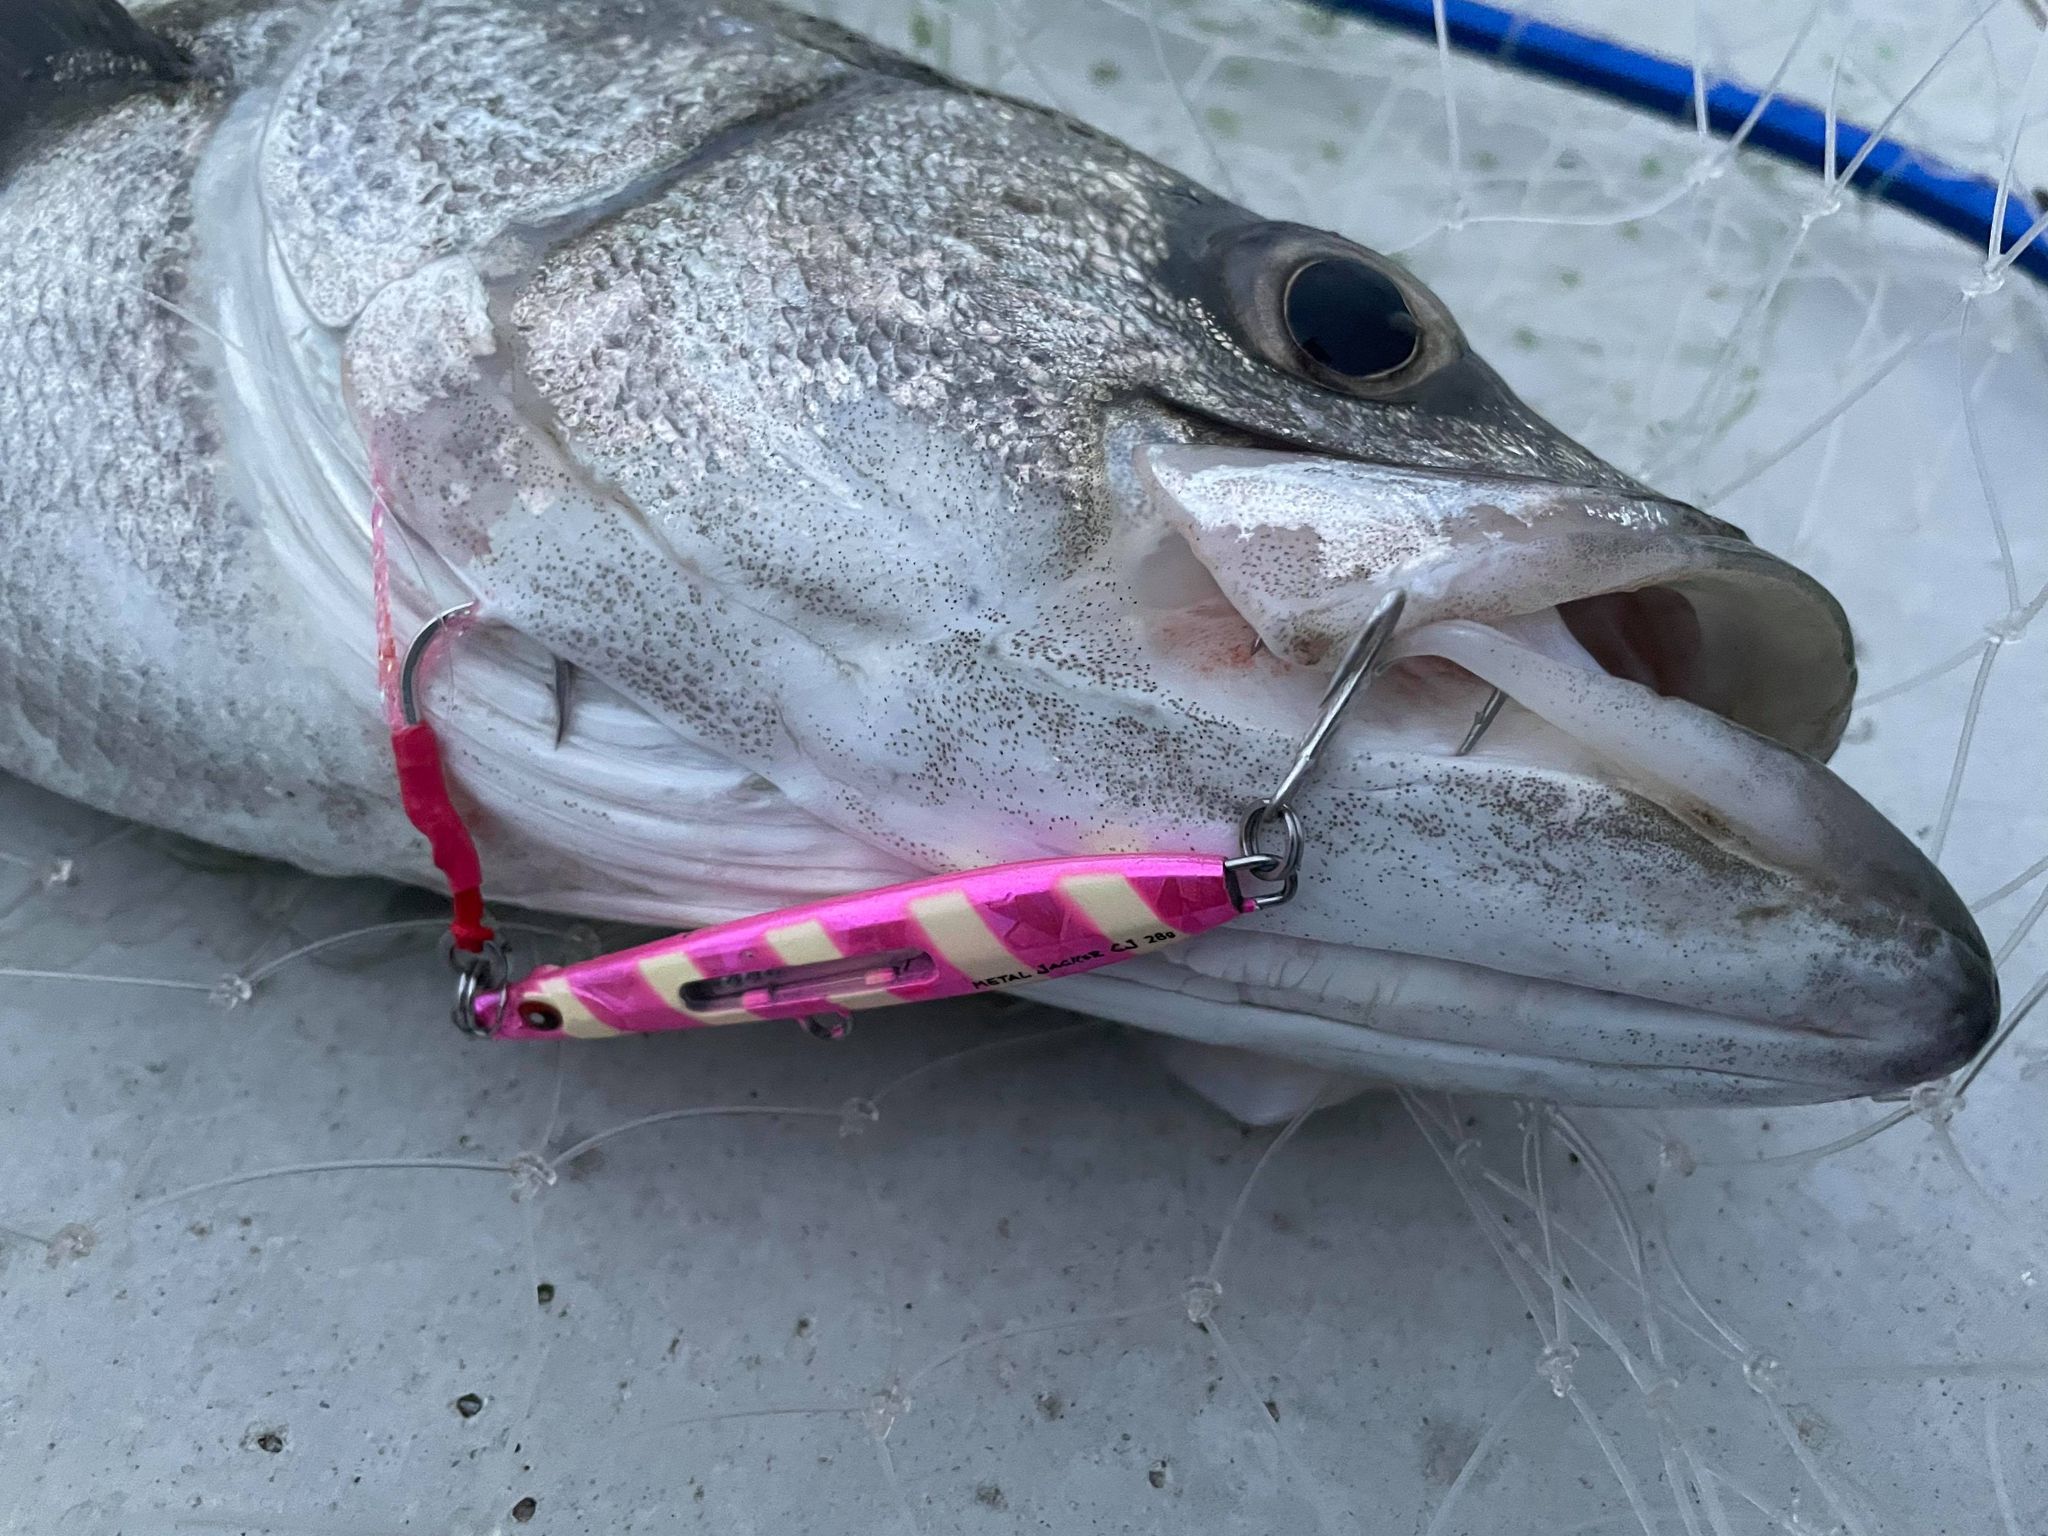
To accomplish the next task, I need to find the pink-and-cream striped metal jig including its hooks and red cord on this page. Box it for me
[389,581,1400,1040]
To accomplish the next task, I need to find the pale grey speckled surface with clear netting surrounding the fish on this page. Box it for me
[0,0,2048,1536]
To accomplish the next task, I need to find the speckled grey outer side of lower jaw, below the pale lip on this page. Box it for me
[1053,745,1997,1104]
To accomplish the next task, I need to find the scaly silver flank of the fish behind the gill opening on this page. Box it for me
[0,81,411,868]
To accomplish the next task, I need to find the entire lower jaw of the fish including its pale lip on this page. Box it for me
[1105,610,1997,1104]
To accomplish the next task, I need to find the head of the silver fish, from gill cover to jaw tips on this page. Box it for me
[346,78,1997,1102]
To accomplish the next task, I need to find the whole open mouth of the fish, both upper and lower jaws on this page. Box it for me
[1040,444,1999,1104]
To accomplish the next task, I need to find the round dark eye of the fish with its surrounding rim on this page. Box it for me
[1208,223,1464,401]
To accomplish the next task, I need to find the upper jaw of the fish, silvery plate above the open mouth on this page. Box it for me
[1135,444,1855,758]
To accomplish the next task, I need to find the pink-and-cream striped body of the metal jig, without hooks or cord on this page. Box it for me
[471,854,1257,1040]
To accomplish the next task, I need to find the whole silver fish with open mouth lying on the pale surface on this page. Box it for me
[0,0,1999,1104]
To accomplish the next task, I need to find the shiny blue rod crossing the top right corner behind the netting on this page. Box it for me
[1311,0,2048,285]
